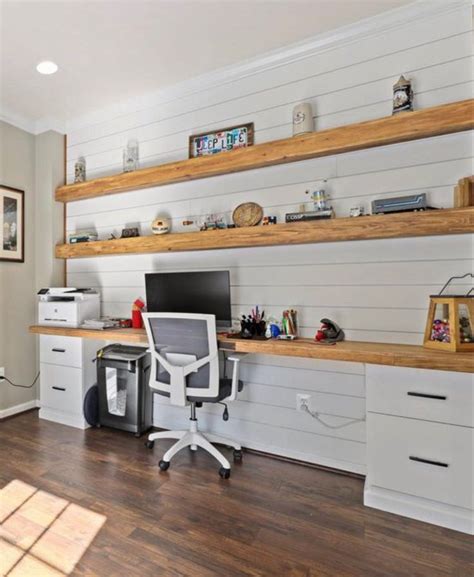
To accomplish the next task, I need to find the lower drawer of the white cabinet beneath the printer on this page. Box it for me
[40,363,83,414]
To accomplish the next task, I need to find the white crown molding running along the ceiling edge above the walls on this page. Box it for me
[1,0,474,134]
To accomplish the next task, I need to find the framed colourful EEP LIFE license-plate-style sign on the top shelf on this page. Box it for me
[189,122,254,158]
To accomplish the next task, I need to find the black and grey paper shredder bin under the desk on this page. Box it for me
[97,344,153,437]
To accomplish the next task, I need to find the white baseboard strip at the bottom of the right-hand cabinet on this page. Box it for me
[364,483,474,535]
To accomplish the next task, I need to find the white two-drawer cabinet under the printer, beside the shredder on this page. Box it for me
[39,335,104,429]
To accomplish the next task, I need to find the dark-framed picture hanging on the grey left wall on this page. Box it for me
[0,184,25,262]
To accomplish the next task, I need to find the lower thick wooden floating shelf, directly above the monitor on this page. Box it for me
[56,207,474,259]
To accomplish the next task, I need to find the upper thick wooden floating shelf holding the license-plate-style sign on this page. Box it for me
[56,99,474,202]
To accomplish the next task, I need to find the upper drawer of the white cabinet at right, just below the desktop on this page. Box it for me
[366,365,474,427]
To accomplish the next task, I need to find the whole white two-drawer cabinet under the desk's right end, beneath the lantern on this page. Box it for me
[364,365,474,534]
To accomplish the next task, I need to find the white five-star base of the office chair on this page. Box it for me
[148,419,242,470]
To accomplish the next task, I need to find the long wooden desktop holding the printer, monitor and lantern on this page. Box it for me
[30,325,474,373]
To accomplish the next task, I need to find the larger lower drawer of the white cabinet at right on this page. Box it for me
[367,413,474,508]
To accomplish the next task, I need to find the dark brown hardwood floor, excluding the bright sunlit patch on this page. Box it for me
[0,412,474,577]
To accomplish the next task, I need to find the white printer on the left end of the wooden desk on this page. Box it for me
[38,287,100,327]
